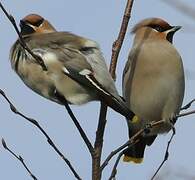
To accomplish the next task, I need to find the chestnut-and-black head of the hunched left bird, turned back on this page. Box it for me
[20,14,56,35]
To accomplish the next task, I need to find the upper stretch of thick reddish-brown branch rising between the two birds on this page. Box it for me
[110,0,134,80]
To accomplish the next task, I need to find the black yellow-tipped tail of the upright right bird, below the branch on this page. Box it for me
[123,135,156,164]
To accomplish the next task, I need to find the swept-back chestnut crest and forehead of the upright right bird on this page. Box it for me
[132,18,171,33]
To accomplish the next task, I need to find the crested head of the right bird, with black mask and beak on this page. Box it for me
[132,18,181,43]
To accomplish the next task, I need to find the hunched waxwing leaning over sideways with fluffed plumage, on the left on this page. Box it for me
[10,14,134,119]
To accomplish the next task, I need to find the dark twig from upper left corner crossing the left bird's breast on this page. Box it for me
[0,2,47,71]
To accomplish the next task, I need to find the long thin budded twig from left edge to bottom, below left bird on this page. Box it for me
[0,89,81,180]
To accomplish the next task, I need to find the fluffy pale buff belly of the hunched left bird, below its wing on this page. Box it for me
[18,61,95,105]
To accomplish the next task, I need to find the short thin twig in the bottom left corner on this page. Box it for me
[1,139,37,180]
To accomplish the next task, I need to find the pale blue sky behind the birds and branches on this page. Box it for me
[0,0,195,180]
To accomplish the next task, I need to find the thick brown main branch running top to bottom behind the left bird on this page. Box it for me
[92,0,134,180]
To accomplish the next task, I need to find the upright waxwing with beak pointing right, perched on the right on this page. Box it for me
[123,18,185,163]
